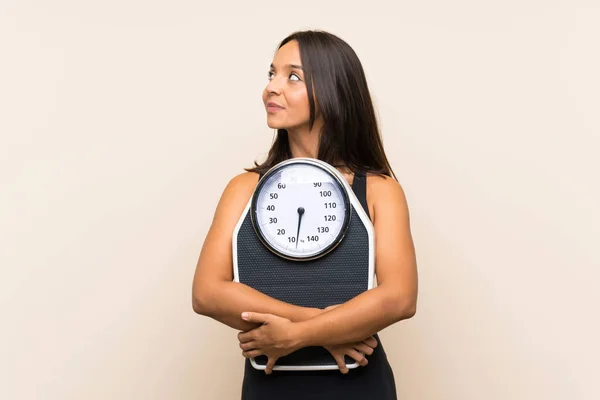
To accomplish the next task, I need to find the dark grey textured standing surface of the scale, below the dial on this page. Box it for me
[234,205,370,367]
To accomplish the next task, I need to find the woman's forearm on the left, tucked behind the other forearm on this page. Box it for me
[193,281,322,331]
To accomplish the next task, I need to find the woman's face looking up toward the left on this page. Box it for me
[262,40,310,132]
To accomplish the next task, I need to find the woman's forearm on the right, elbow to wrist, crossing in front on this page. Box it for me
[295,286,416,347]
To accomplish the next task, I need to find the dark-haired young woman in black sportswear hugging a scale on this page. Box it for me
[193,31,418,400]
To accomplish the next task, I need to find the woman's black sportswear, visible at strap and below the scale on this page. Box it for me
[242,173,397,400]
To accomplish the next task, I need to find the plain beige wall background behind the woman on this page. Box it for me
[0,0,600,400]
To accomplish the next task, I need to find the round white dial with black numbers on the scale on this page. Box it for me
[254,163,350,258]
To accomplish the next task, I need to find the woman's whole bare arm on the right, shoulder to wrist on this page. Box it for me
[293,177,418,347]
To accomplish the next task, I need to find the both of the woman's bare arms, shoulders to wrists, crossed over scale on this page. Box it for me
[192,173,418,372]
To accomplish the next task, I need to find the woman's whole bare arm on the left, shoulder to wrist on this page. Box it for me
[192,173,322,332]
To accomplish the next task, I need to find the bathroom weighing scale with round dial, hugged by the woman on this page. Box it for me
[233,158,375,370]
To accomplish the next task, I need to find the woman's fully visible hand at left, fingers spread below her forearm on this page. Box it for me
[238,312,301,374]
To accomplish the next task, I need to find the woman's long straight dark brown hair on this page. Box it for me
[245,30,396,178]
